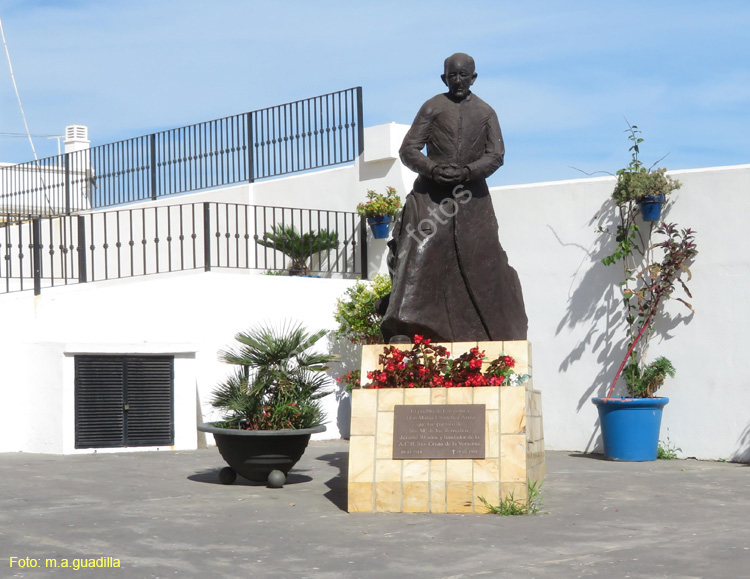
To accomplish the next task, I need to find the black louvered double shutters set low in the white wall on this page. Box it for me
[75,356,174,448]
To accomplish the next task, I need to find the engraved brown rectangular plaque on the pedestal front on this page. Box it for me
[393,404,485,460]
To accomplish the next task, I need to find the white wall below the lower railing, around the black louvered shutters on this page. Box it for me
[0,271,360,454]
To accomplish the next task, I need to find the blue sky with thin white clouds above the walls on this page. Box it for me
[0,0,750,185]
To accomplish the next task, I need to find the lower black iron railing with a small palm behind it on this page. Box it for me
[0,202,367,294]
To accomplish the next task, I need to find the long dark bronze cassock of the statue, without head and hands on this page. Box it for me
[381,92,528,342]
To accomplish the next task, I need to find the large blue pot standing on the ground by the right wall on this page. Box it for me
[591,397,669,462]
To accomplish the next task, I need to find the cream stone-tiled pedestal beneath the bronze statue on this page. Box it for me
[348,341,545,513]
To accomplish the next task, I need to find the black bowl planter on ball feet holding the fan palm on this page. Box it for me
[198,422,326,487]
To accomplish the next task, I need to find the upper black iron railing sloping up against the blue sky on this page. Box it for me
[0,87,364,224]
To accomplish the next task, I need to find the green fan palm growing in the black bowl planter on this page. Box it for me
[211,323,333,430]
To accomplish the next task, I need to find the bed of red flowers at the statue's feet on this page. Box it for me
[365,335,528,388]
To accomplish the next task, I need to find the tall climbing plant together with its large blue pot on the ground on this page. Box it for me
[592,126,698,461]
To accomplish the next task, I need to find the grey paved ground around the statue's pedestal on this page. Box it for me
[0,441,750,579]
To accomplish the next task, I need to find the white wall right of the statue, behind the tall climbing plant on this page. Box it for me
[492,165,750,460]
